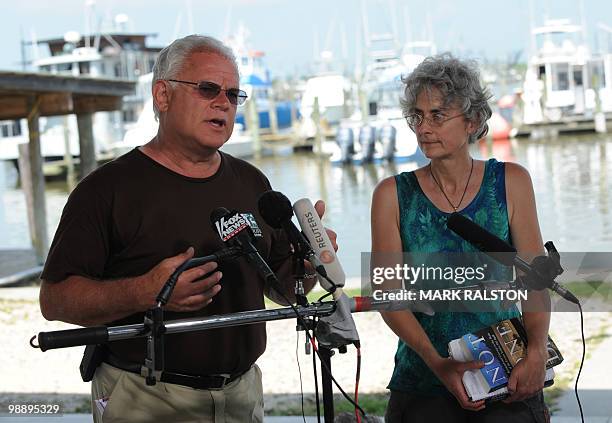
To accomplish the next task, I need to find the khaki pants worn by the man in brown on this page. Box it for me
[91,363,263,423]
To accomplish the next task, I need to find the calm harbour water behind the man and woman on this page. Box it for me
[0,135,612,276]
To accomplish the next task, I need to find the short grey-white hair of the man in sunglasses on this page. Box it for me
[151,35,238,119]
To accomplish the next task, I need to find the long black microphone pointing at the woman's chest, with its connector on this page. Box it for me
[446,213,579,304]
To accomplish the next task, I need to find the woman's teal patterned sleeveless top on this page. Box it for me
[388,159,519,395]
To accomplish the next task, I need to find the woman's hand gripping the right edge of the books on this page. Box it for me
[504,349,548,403]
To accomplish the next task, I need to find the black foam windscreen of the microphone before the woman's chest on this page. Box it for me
[446,213,516,266]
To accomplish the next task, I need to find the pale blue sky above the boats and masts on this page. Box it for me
[0,0,612,77]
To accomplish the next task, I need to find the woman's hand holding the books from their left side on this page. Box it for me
[431,358,485,411]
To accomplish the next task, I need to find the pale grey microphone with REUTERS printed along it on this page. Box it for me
[293,198,346,291]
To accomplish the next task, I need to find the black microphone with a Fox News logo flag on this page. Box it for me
[210,207,278,283]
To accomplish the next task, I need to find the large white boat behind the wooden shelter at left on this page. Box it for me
[0,15,161,163]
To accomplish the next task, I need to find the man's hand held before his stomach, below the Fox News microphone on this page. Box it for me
[138,247,222,312]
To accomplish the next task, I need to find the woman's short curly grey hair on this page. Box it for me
[400,53,492,143]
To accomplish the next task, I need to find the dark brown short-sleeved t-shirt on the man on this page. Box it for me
[42,149,290,375]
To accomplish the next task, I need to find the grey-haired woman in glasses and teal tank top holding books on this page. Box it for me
[372,54,550,422]
